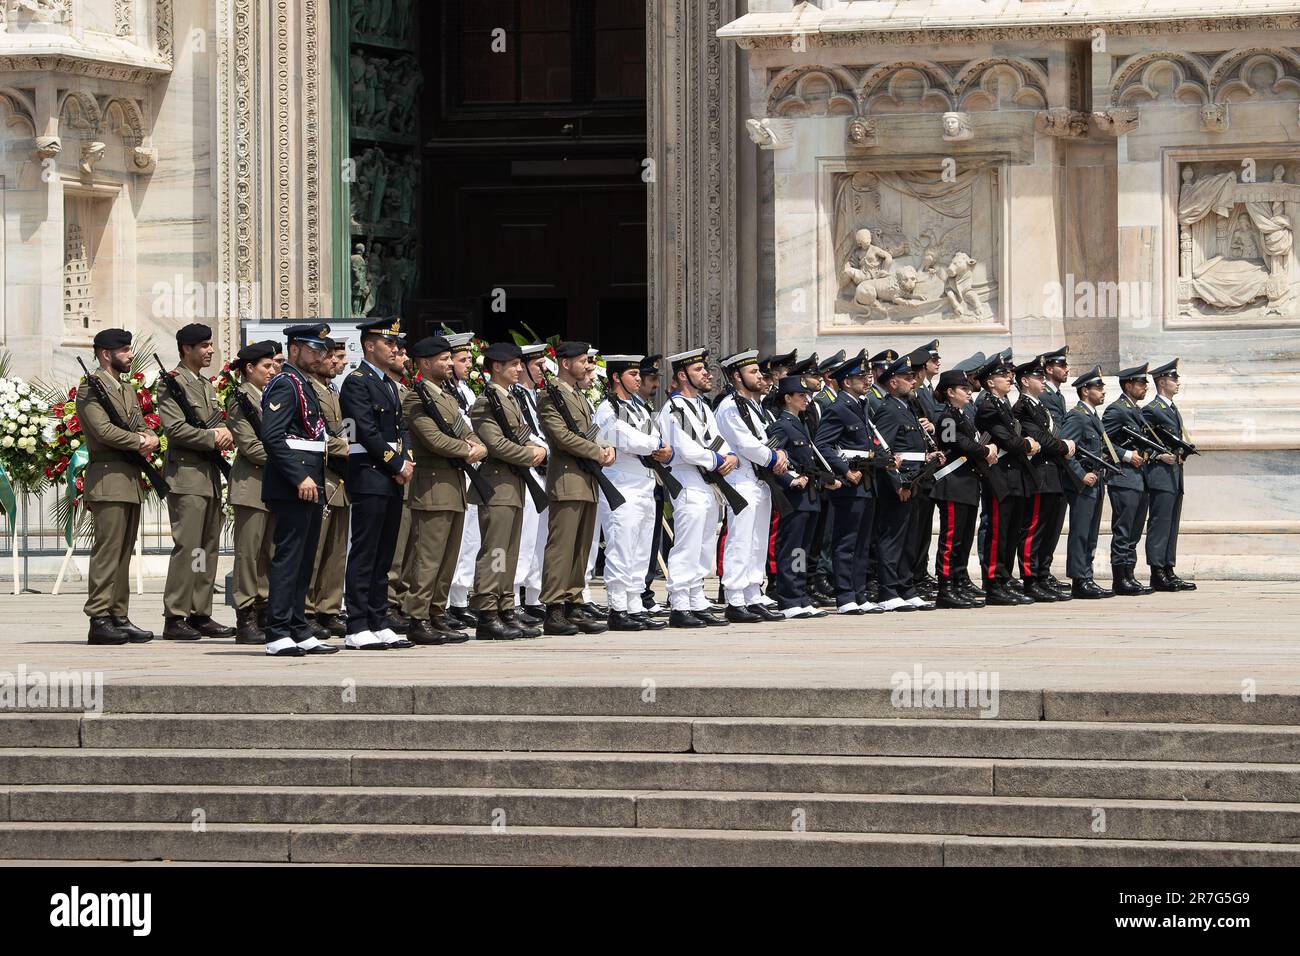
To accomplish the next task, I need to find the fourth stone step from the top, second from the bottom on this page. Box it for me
[0,786,1300,843]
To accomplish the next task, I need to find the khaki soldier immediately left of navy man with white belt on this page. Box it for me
[226,342,276,644]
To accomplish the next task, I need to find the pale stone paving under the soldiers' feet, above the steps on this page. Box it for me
[0,581,1300,695]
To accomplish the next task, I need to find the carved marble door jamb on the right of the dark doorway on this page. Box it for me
[646,0,748,355]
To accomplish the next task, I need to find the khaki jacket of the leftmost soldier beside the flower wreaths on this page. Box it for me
[77,369,147,503]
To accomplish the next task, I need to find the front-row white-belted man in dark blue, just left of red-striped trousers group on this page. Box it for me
[874,350,939,611]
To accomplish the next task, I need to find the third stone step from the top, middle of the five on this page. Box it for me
[0,748,1300,804]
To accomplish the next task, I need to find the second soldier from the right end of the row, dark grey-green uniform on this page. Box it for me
[1101,362,1151,597]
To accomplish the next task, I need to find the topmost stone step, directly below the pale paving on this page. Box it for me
[17,686,1300,728]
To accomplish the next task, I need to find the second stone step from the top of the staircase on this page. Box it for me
[17,711,1300,763]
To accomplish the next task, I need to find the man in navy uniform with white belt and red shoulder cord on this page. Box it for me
[261,324,338,657]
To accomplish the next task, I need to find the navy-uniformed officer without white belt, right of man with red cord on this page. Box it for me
[339,319,415,650]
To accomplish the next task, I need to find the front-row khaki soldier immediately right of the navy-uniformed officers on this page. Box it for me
[402,336,488,644]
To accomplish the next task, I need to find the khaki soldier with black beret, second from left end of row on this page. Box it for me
[159,323,234,641]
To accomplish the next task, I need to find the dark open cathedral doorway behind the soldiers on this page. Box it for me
[406,0,647,351]
